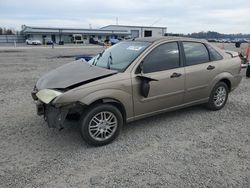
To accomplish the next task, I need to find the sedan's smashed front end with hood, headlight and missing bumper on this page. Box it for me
[31,61,117,129]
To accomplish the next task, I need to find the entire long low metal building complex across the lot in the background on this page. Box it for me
[21,25,167,44]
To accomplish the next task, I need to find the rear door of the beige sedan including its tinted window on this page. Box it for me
[182,42,220,103]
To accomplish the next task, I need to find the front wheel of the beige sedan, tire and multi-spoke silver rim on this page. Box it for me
[80,104,123,146]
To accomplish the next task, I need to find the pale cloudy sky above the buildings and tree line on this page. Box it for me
[0,0,250,34]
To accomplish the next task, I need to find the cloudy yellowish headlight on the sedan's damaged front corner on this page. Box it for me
[36,89,62,104]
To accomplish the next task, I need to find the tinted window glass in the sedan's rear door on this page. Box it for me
[183,42,209,66]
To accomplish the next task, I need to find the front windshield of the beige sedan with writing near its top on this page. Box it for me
[88,41,151,72]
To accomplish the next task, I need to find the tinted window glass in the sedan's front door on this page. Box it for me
[143,42,180,73]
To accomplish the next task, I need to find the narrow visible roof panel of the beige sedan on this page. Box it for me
[133,36,207,43]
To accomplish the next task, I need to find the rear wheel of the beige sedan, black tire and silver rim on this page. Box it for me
[206,82,229,111]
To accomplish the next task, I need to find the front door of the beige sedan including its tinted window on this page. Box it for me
[132,42,185,117]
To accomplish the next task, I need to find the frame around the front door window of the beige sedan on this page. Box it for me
[140,41,184,74]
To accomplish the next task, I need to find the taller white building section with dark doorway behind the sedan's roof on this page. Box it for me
[101,25,167,38]
